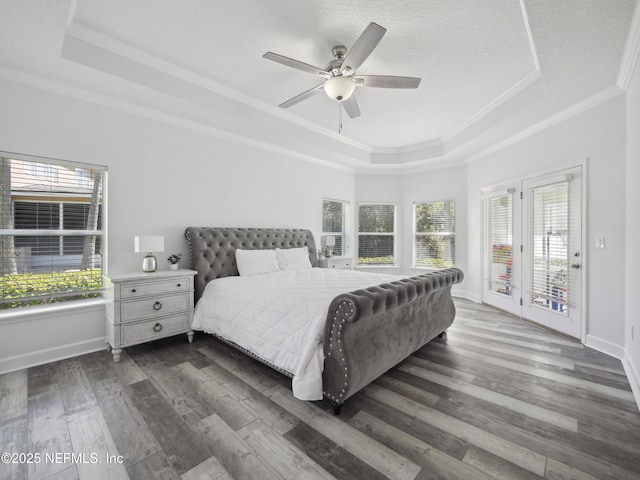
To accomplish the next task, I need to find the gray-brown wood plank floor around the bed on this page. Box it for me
[0,300,640,480]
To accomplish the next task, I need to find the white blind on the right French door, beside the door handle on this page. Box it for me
[528,181,569,312]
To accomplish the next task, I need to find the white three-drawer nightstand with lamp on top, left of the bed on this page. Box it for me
[105,270,196,362]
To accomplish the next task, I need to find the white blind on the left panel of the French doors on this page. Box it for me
[484,191,514,297]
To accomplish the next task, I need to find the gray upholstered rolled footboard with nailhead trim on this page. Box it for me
[323,268,463,413]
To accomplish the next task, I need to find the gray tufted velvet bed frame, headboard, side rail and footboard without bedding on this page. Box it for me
[185,227,463,414]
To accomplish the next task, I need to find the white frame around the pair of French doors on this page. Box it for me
[479,157,590,344]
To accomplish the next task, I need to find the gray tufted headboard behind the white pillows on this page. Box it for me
[184,227,318,302]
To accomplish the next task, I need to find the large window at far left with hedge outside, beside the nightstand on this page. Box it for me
[0,155,106,309]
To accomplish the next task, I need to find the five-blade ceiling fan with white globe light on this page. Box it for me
[263,22,420,118]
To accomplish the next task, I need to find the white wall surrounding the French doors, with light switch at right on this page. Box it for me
[466,94,626,357]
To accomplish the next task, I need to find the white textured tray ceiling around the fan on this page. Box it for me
[0,0,636,170]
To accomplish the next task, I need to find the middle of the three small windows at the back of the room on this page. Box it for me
[358,204,396,266]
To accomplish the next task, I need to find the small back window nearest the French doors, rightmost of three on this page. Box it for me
[413,200,456,268]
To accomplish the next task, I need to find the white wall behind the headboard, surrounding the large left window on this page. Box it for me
[0,80,355,372]
